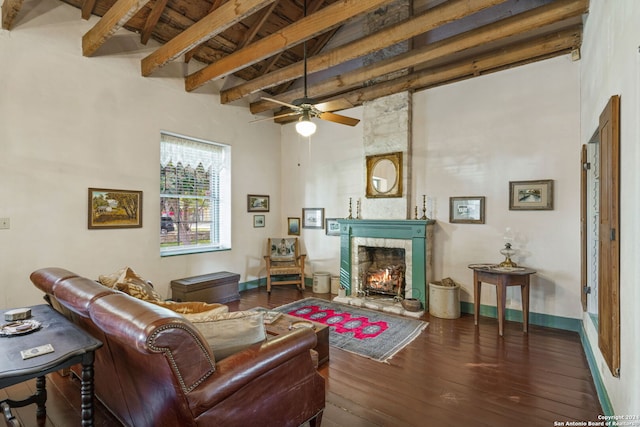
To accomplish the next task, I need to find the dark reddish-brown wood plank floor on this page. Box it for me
[0,286,602,427]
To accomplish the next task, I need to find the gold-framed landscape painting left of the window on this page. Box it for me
[88,188,142,229]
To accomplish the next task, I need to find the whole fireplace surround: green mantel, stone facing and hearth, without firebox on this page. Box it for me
[336,219,435,317]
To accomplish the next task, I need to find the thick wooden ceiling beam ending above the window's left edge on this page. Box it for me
[142,0,275,77]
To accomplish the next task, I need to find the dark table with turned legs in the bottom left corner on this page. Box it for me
[0,304,102,426]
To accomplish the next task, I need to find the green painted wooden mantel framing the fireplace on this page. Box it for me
[338,219,435,307]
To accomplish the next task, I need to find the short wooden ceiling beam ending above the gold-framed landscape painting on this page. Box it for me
[82,0,149,56]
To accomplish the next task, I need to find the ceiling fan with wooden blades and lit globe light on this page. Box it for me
[262,0,360,136]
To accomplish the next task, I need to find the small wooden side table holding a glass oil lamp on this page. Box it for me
[469,264,535,336]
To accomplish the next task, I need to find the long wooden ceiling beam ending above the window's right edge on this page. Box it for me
[220,0,507,104]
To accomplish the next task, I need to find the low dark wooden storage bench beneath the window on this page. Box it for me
[171,271,240,303]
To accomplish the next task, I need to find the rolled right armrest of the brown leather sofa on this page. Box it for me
[190,328,317,410]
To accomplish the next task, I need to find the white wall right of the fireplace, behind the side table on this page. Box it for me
[413,55,581,318]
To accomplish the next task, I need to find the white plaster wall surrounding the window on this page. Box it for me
[0,0,281,308]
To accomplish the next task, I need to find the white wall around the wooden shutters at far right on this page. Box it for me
[581,0,640,415]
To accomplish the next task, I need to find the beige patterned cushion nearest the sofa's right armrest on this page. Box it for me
[193,311,267,360]
